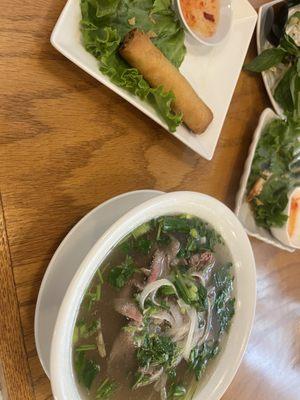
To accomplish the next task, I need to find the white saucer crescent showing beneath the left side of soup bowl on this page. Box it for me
[34,190,164,377]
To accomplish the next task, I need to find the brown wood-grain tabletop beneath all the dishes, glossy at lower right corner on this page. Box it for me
[0,0,300,400]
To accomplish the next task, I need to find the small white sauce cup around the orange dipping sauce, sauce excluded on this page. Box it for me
[175,0,232,46]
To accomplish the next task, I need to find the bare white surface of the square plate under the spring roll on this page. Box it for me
[51,0,257,160]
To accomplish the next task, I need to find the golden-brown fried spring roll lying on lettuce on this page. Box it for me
[119,29,213,133]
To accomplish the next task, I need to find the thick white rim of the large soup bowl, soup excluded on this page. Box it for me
[51,192,256,400]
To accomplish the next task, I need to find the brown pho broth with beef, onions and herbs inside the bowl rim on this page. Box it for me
[73,215,234,400]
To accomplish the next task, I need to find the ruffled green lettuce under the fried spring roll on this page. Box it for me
[81,0,186,131]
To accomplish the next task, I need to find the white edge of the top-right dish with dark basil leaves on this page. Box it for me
[256,0,300,116]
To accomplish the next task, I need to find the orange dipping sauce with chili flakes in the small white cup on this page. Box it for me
[180,0,220,37]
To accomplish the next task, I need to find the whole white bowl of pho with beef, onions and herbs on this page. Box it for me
[51,192,256,400]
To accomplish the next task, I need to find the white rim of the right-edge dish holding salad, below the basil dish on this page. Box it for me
[235,108,295,252]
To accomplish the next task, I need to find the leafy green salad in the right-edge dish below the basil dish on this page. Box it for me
[247,119,300,229]
